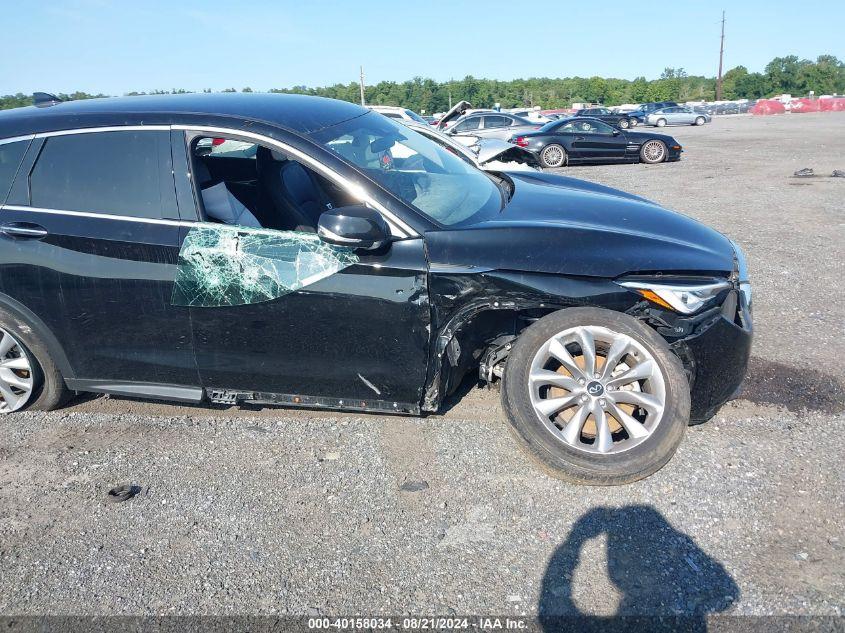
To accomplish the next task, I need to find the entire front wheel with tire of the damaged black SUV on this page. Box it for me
[502,308,690,485]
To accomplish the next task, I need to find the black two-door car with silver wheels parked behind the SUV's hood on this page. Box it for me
[510,117,683,167]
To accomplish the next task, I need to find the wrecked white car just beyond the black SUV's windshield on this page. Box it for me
[403,121,539,171]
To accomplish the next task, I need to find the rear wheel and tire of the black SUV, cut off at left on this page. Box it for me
[0,309,71,415]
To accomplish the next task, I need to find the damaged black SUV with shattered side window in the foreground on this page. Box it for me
[0,94,752,484]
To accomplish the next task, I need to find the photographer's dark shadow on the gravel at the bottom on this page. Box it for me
[538,505,740,631]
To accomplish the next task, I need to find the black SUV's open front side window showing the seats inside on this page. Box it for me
[191,137,357,233]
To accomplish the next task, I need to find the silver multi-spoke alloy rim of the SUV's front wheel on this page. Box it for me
[528,326,666,454]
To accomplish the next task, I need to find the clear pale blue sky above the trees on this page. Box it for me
[0,0,845,95]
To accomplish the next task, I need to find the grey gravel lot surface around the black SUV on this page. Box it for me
[0,113,845,615]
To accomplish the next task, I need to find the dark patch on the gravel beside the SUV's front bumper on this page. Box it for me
[738,357,845,414]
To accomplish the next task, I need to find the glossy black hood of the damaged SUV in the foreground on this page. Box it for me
[426,173,734,279]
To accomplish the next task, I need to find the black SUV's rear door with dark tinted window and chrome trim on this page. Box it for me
[0,127,198,388]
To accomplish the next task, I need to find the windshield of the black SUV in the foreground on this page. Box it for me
[311,113,502,226]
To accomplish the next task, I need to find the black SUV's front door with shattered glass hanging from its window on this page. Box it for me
[174,134,430,411]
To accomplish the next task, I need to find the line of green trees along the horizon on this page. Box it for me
[0,55,845,114]
